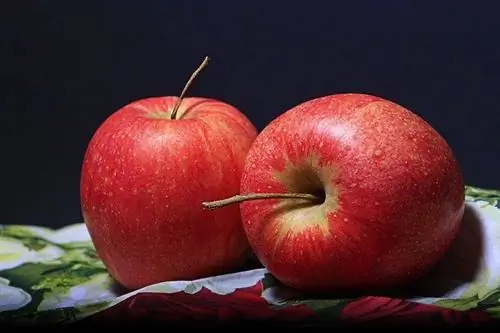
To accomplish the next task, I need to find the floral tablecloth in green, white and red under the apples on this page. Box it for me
[0,187,500,326]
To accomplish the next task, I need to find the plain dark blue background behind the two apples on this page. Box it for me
[0,0,500,226]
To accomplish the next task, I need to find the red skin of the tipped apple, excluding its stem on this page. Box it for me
[240,94,465,292]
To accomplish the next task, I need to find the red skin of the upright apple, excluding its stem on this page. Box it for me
[80,96,257,289]
